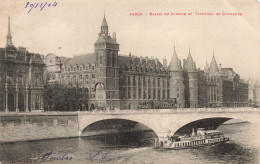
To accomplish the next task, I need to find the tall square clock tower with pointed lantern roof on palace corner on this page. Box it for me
[94,15,120,109]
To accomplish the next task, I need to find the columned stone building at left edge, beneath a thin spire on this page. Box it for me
[0,18,44,112]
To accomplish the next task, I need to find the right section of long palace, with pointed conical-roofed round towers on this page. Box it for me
[169,49,248,108]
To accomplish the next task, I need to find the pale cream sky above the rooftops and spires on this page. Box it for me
[0,0,260,79]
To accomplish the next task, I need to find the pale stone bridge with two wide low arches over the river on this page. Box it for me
[78,108,260,137]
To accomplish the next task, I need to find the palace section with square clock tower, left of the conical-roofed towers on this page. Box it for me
[55,17,171,109]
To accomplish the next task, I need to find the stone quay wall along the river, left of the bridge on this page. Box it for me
[0,113,79,143]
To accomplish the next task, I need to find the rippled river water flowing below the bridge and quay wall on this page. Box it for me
[0,123,260,164]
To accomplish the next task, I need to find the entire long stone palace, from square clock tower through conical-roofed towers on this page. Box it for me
[45,17,248,110]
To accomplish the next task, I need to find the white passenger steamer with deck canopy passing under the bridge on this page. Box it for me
[154,128,229,149]
